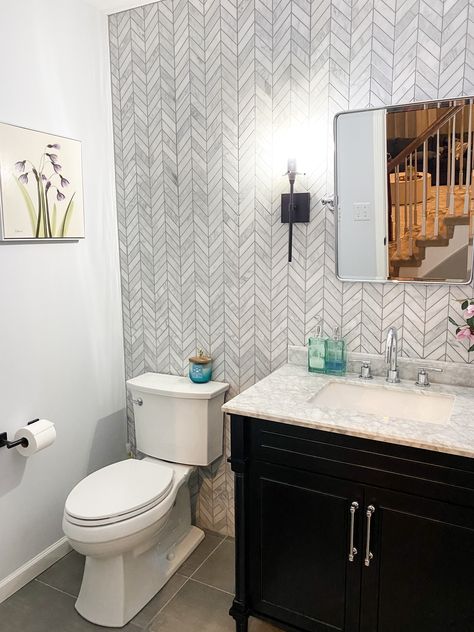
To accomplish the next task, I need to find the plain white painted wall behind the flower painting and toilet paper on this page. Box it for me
[0,0,125,581]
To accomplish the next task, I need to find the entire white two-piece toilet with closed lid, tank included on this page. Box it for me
[63,373,228,627]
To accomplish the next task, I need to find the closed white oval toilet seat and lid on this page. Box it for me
[64,459,174,527]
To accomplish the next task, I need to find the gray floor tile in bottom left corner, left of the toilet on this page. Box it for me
[0,580,139,632]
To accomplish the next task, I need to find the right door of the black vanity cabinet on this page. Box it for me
[361,489,474,632]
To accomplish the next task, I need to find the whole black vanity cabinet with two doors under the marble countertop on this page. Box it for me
[231,415,474,632]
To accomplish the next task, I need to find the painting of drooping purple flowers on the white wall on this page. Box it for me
[0,123,84,241]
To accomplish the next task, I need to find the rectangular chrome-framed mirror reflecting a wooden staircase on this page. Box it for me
[334,98,474,284]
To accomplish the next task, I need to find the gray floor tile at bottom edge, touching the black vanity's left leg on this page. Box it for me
[149,581,235,632]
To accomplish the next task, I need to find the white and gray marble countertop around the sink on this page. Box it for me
[223,364,474,458]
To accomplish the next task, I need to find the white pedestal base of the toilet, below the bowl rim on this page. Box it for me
[76,484,204,628]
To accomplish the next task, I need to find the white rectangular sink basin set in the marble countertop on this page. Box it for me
[309,382,454,424]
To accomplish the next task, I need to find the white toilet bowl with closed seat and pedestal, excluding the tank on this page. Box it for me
[63,458,204,627]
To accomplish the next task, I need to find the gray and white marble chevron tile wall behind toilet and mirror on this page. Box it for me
[110,0,474,533]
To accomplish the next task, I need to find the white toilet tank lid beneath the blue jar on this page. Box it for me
[127,373,229,399]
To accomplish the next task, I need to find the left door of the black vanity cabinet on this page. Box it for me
[247,462,362,632]
